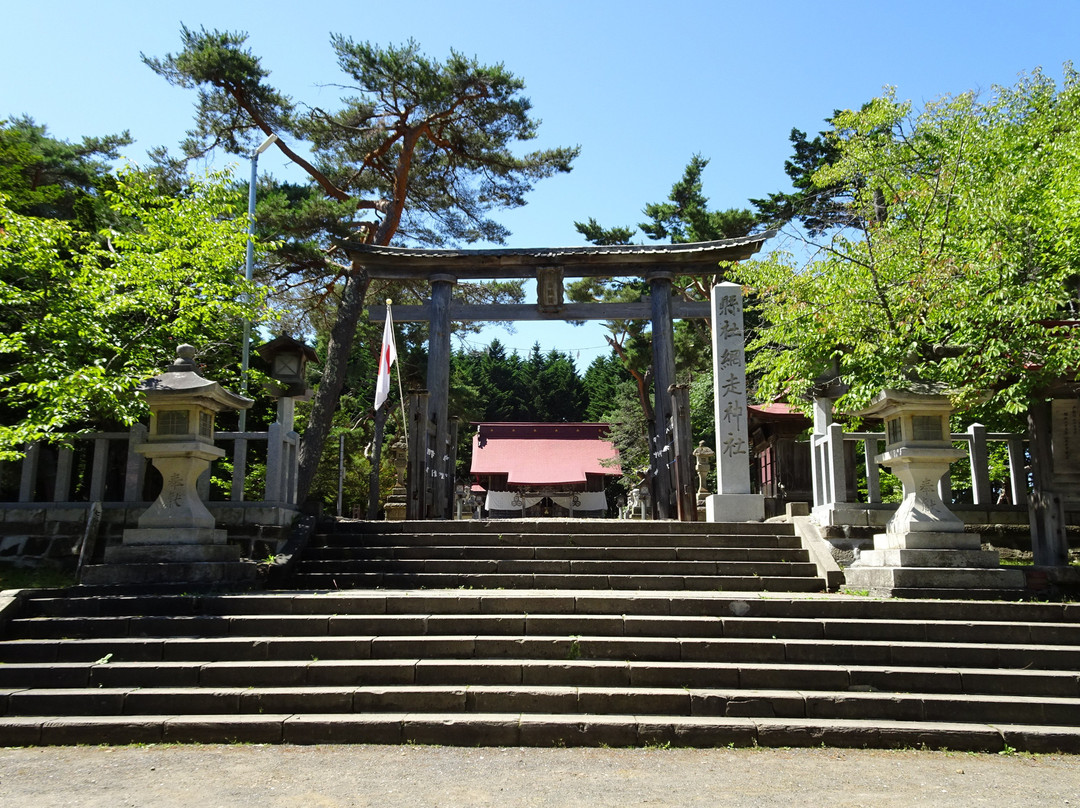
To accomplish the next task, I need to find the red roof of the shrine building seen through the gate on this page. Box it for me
[472,422,622,485]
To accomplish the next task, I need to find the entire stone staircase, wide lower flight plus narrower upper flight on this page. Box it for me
[0,523,1080,753]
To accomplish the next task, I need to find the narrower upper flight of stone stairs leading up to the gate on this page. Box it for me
[287,520,825,592]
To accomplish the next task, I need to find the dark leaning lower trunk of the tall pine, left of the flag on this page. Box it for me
[297,266,369,504]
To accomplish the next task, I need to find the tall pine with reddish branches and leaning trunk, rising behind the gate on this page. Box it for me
[150,27,577,499]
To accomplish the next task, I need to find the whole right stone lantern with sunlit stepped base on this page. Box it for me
[845,390,1025,597]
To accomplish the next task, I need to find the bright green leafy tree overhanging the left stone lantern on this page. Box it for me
[0,172,261,457]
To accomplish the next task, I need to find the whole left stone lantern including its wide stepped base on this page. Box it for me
[82,345,255,584]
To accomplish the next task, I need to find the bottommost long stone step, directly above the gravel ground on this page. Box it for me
[0,713,1080,753]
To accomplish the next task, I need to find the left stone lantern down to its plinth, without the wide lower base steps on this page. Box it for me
[124,345,253,546]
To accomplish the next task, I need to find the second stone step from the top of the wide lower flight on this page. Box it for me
[8,612,1080,648]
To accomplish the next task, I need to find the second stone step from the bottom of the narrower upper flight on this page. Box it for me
[297,558,818,578]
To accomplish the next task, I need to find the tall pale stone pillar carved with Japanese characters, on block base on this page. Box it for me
[705,283,765,522]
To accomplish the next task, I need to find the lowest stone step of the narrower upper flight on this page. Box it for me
[280,568,825,592]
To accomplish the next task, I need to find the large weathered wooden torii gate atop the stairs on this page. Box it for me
[343,231,772,519]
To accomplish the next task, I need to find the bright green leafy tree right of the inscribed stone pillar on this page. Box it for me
[732,66,1080,413]
